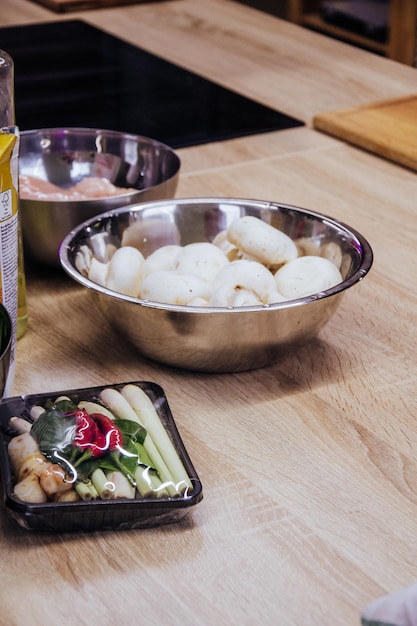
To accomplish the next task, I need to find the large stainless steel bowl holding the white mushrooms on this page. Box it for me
[60,198,373,372]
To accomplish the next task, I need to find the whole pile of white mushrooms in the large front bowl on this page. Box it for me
[76,216,343,307]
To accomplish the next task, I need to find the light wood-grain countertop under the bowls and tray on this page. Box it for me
[0,0,417,626]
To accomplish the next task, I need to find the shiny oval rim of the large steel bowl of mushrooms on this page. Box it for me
[58,197,374,315]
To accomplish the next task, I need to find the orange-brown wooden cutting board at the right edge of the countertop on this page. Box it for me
[313,94,417,170]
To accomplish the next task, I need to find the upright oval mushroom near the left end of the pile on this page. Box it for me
[106,246,145,298]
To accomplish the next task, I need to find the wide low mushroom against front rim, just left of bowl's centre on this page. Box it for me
[140,270,211,305]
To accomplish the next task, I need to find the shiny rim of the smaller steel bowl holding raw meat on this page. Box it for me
[19,126,181,205]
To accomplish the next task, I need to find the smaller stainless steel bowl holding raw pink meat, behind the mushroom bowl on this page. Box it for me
[19,128,180,267]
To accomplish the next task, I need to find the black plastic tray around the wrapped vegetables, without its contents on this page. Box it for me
[0,381,203,532]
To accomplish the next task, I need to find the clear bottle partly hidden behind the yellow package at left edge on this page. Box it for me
[0,50,28,339]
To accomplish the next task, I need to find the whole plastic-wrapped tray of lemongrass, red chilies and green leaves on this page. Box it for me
[0,382,203,532]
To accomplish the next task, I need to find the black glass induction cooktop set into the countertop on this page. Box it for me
[0,20,303,148]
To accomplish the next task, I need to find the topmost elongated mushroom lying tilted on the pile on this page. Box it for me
[227,215,298,269]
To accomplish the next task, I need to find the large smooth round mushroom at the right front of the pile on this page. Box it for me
[275,256,343,300]
